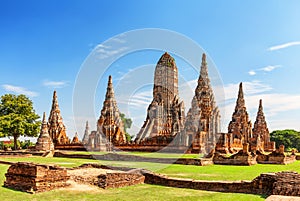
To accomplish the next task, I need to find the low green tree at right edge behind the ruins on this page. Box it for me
[270,129,300,150]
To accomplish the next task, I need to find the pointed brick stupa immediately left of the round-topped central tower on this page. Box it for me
[96,76,126,151]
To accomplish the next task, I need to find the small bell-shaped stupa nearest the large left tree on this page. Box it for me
[35,112,54,151]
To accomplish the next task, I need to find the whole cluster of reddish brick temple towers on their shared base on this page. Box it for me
[39,52,275,157]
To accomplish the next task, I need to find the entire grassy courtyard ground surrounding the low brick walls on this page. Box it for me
[0,151,300,200]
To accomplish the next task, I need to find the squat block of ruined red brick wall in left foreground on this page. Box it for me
[4,162,69,193]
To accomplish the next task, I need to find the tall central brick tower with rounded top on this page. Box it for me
[135,52,185,145]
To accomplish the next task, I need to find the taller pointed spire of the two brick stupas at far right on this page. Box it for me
[228,83,252,149]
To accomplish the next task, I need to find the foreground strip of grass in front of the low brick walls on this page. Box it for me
[0,163,264,201]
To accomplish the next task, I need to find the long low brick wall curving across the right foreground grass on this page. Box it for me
[144,172,300,196]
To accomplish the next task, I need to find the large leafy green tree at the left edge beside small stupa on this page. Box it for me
[0,94,41,149]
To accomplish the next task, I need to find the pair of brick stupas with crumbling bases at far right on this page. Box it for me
[216,83,275,153]
